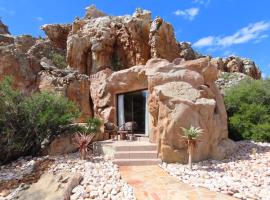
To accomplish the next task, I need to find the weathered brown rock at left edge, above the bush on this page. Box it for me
[0,36,41,94]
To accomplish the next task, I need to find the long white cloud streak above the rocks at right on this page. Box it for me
[193,21,270,48]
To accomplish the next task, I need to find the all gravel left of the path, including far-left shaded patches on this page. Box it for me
[0,152,136,200]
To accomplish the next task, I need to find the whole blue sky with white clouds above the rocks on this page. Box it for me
[0,0,270,76]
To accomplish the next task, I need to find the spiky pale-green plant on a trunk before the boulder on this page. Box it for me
[181,126,203,169]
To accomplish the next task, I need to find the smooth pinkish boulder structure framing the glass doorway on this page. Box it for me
[90,58,234,162]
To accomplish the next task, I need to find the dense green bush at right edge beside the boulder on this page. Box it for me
[225,79,270,142]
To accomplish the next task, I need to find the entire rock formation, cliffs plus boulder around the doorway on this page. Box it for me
[0,6,261,162]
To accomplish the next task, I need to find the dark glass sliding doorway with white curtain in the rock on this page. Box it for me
[117,90,150,136]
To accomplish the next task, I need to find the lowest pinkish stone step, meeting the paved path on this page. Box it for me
[113,158,161,166]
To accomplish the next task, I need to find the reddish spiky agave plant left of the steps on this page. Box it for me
[73,132,95,160]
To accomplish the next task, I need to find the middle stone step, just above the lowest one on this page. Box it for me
[114,151,157,159]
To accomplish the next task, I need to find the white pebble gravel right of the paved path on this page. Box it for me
[160,141,270,200]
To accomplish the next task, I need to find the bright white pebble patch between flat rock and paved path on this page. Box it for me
[50,154,136,200]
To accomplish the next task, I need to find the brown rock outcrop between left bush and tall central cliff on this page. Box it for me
[38,58,93,121]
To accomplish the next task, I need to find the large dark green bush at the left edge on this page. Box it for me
[0,78,79,162]
